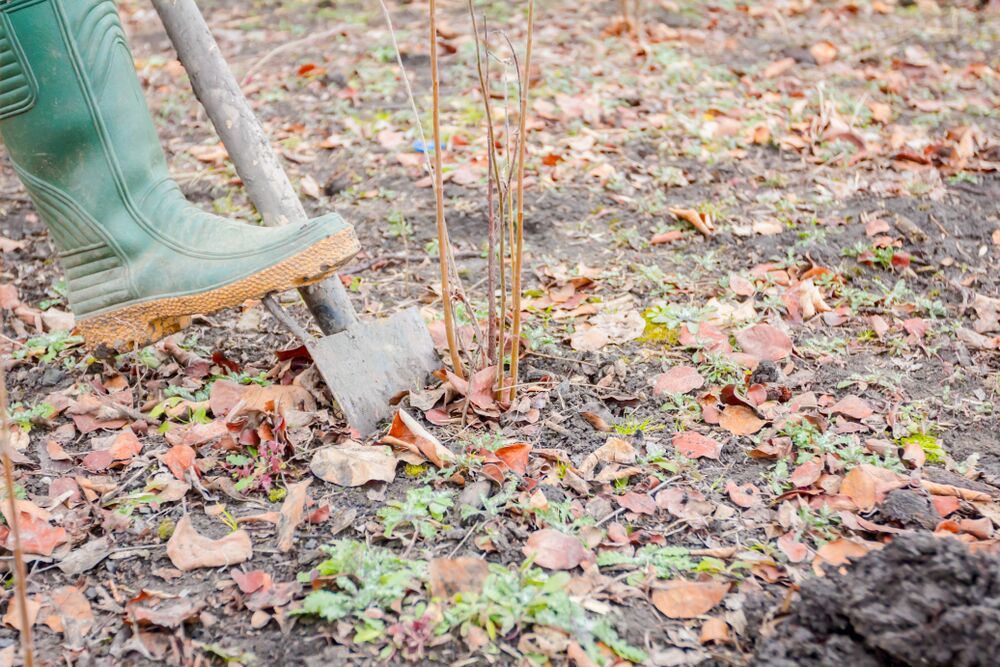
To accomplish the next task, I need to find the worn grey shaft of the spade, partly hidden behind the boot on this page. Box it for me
[153,0,358,335]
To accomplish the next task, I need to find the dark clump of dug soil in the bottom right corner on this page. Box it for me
[752,533,1000,667]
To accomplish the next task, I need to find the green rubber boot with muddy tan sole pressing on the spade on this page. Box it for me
[0,0,358,348]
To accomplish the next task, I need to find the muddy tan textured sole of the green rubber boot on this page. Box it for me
[78,229,360,350]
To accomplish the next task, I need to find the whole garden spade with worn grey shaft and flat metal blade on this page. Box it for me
[153,0,441,436]
